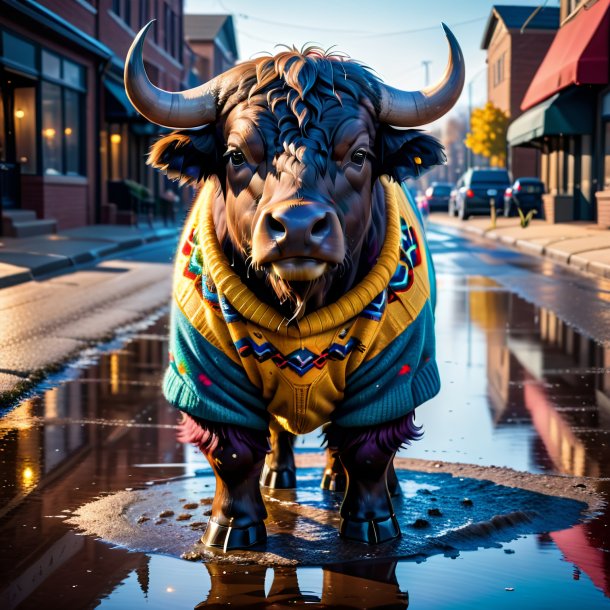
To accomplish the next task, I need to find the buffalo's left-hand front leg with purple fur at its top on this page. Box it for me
[179,416,268,551]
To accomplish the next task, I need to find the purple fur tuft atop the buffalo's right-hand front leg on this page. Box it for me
[324,411,424,454]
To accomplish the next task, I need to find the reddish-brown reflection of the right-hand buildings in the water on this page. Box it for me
[469,282,610,596]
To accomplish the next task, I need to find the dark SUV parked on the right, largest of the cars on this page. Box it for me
[455,167,511,220]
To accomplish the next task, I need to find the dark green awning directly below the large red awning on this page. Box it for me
[506,87,595,146]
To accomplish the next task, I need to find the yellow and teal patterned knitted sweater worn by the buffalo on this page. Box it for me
[164,177,440,434]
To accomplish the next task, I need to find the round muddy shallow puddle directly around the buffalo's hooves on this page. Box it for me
[67,468,587,566]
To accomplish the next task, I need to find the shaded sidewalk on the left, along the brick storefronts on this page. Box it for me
[0,223,179,288]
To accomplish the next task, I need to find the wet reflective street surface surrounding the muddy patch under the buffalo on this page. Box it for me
[0,226,610,608]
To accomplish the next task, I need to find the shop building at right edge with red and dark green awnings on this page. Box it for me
[507,0,610,227]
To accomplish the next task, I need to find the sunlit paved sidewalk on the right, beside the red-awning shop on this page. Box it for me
[429,213,610,278]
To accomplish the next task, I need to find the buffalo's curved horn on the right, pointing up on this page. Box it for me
[379,23,465,127]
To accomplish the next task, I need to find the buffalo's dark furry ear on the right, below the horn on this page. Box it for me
[377,125,447,182]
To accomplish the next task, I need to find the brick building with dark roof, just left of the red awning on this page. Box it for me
[481,5,559,178]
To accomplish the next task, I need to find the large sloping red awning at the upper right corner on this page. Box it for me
[521,0,610,110]
